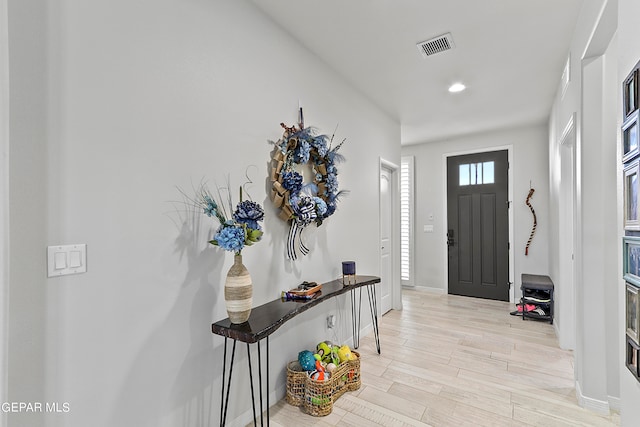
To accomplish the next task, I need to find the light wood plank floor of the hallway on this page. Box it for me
[270,290,620,427]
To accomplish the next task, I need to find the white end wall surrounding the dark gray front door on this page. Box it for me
[402,125,549,296]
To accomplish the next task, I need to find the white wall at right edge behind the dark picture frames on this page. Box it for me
[616,0,640,426]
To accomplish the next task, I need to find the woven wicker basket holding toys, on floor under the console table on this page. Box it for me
[286,351,362,417]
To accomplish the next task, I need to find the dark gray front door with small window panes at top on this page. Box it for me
[447,150,509,301]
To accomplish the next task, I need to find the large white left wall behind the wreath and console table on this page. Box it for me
[9,0,400,426]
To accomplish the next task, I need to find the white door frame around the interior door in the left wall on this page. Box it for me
[378,157,402,314]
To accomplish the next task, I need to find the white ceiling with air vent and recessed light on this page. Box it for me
[253,0,582,144]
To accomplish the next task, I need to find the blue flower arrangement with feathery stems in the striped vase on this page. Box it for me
[196,185,264,255]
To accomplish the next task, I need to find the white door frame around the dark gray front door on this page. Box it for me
[441,145,515,302]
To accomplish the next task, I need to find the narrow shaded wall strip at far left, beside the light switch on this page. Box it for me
[5,0,48,426]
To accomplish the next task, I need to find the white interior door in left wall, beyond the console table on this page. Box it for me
[380,166,394,314]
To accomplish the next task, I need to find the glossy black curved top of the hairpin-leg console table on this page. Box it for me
[211,276,380,343]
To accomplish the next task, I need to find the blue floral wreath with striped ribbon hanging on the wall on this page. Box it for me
[271,113,345,260]
